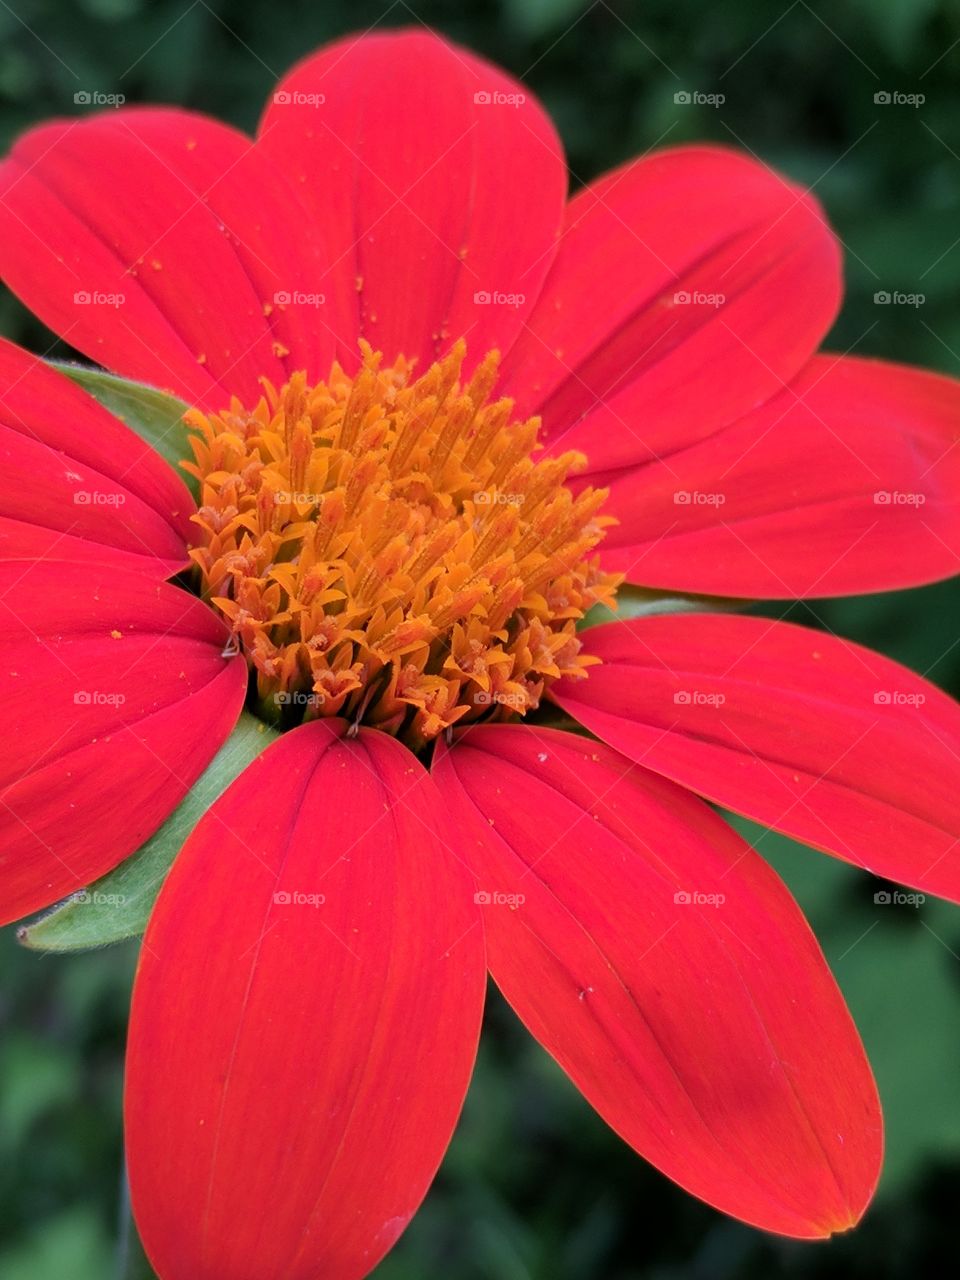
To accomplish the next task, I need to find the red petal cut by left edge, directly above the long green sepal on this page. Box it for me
[0,561,246,923]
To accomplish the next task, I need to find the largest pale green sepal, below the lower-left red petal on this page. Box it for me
[17,712,278,951]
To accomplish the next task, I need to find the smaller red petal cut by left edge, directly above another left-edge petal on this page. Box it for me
[0,340,196,577]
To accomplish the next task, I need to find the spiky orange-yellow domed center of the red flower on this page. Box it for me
[183,342,620,749]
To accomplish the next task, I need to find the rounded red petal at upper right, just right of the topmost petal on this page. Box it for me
[504,147,840,470]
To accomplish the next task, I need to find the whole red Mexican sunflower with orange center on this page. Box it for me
[0,32,960,1280]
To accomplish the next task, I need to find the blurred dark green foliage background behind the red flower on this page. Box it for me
[0,0,960,1280]
